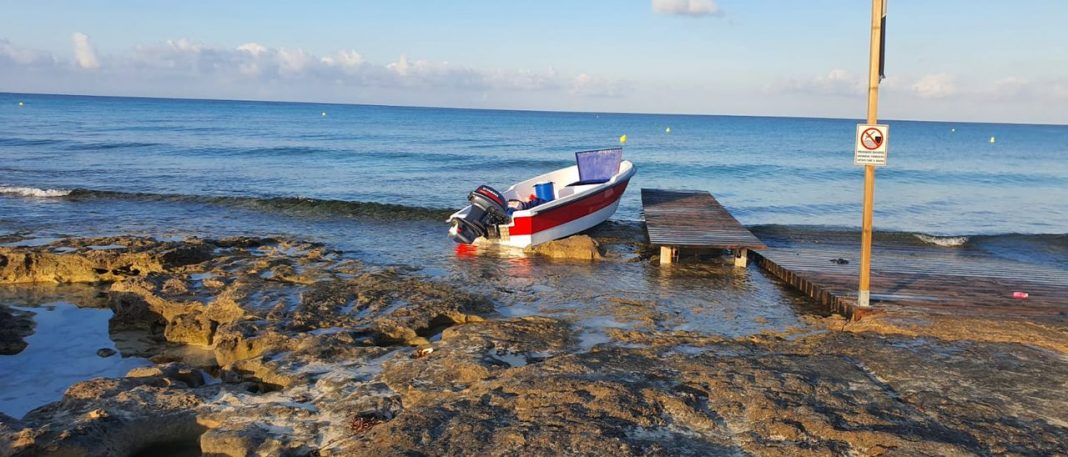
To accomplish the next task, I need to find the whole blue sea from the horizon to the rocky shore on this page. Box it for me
[0,94,1068,334]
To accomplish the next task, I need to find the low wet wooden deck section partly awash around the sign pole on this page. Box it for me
[755,233,1068,321]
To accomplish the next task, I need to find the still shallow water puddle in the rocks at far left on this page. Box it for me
[0,302,152,417]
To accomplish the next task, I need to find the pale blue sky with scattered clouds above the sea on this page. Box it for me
[0,0,1068,124]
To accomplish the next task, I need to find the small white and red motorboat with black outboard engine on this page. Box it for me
[449,148,635,248]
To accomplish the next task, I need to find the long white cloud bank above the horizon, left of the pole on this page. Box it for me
[0,34,624,108]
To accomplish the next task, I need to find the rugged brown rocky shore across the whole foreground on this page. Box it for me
[0,237,1068,456]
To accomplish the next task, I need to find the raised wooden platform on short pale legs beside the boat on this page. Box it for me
[642,189,767,268]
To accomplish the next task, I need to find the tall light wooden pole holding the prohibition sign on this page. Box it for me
[857,0,886,308]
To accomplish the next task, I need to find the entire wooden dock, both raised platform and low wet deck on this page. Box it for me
[642,189,1068,325]
